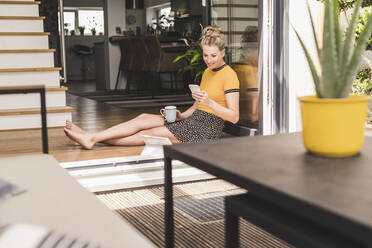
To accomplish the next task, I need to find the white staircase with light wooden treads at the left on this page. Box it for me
[0,0,73,130]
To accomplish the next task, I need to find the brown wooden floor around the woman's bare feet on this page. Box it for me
[0,82,163,162]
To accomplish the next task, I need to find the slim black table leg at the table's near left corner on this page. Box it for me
[164,157,174,248]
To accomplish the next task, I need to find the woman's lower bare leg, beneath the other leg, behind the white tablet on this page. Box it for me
[105,126,181,146]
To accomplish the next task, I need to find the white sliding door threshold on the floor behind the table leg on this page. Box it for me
[60,155,214,192]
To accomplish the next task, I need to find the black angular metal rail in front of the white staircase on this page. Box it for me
[0,87,49,154]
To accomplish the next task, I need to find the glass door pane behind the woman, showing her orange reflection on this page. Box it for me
[211,0,260,135]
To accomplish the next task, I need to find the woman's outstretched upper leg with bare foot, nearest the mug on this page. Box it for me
[64,114,164,149]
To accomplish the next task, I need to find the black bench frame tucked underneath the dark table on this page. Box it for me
[225,192,361,248]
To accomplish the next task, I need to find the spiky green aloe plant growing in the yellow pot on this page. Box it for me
[295,0,372,98]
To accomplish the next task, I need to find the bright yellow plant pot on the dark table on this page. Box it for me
[299,95,370,157]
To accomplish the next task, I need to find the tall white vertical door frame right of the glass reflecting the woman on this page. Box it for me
[259,0,288,135]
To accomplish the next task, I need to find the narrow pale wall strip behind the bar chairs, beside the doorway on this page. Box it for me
[104,0,126,89]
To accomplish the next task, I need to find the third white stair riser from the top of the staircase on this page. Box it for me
[0,35,49,50]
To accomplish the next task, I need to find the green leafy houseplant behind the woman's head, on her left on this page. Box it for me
[173,38,206,84]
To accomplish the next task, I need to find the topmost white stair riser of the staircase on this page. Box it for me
[0,1,40,17]
